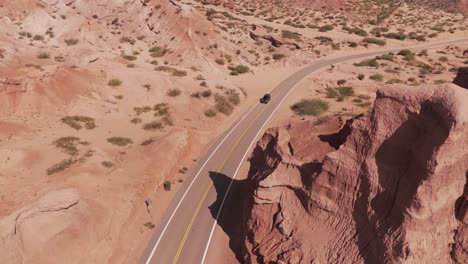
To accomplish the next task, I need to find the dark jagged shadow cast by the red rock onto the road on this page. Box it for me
[209,172,251,263]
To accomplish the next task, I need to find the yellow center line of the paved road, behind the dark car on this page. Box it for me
[172,104,267,264]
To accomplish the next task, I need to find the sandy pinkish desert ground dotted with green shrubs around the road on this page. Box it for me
[0,0,468,263]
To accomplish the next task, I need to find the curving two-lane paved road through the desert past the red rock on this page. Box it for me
[140,39,468,264]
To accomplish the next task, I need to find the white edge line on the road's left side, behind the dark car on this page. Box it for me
[145,102,258,264]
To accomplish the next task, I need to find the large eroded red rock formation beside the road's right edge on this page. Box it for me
[244,84,468,263]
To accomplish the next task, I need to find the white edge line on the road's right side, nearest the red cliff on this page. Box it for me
[201,66,308,264]
